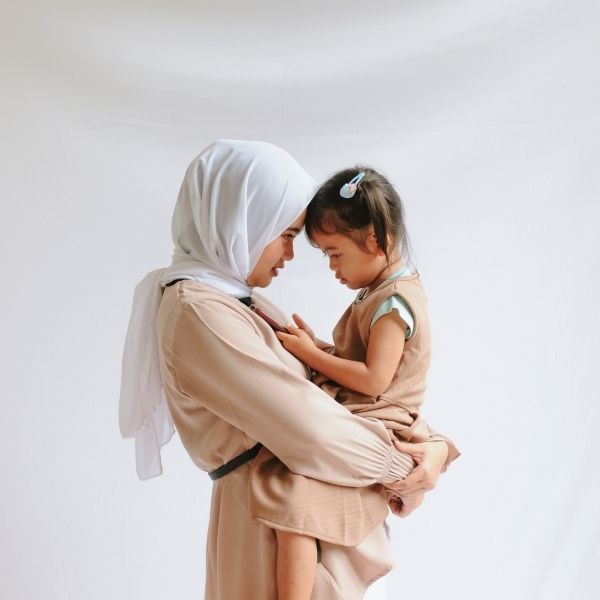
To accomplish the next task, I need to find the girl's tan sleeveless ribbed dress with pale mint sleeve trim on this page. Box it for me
[250,274,458,552]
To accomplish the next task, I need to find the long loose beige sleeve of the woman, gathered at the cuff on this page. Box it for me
[157,297,412,487]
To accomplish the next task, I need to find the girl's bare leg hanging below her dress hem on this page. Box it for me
[275,529,317,600]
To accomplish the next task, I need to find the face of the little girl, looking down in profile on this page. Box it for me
[312,232,387,290]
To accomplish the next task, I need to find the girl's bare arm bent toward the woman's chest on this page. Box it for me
[277,310,407,397]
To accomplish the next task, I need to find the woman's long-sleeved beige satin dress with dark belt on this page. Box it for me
[157,281,424,600]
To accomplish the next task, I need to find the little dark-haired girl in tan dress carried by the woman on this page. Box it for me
[251,167,458,600]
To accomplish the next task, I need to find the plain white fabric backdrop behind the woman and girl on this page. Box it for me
[0,0,600,600]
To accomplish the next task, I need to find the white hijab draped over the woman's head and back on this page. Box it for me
[119,140,314,480]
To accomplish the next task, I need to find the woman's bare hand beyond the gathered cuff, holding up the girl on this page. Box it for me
[385,441,448,496]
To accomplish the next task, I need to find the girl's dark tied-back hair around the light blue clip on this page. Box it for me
[304,165,413,266]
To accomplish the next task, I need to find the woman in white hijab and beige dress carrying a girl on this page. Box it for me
[120,140,460,600]
